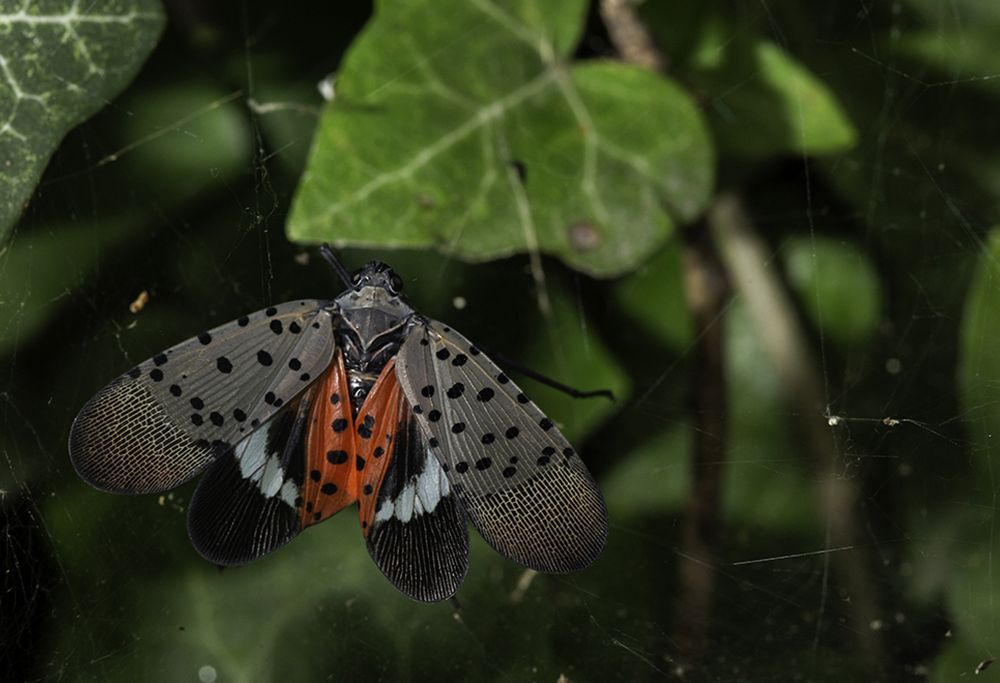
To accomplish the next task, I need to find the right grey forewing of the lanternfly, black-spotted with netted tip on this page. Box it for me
[396,320,608,573]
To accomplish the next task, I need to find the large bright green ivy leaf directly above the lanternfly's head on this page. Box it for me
[288,0,714,276]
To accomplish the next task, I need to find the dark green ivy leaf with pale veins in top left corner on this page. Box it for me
[0,0,163,238]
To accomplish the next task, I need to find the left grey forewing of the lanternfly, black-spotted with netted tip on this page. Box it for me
[69,300,335,493]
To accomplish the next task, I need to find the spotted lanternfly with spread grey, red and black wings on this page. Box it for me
[69,247,608,601]
